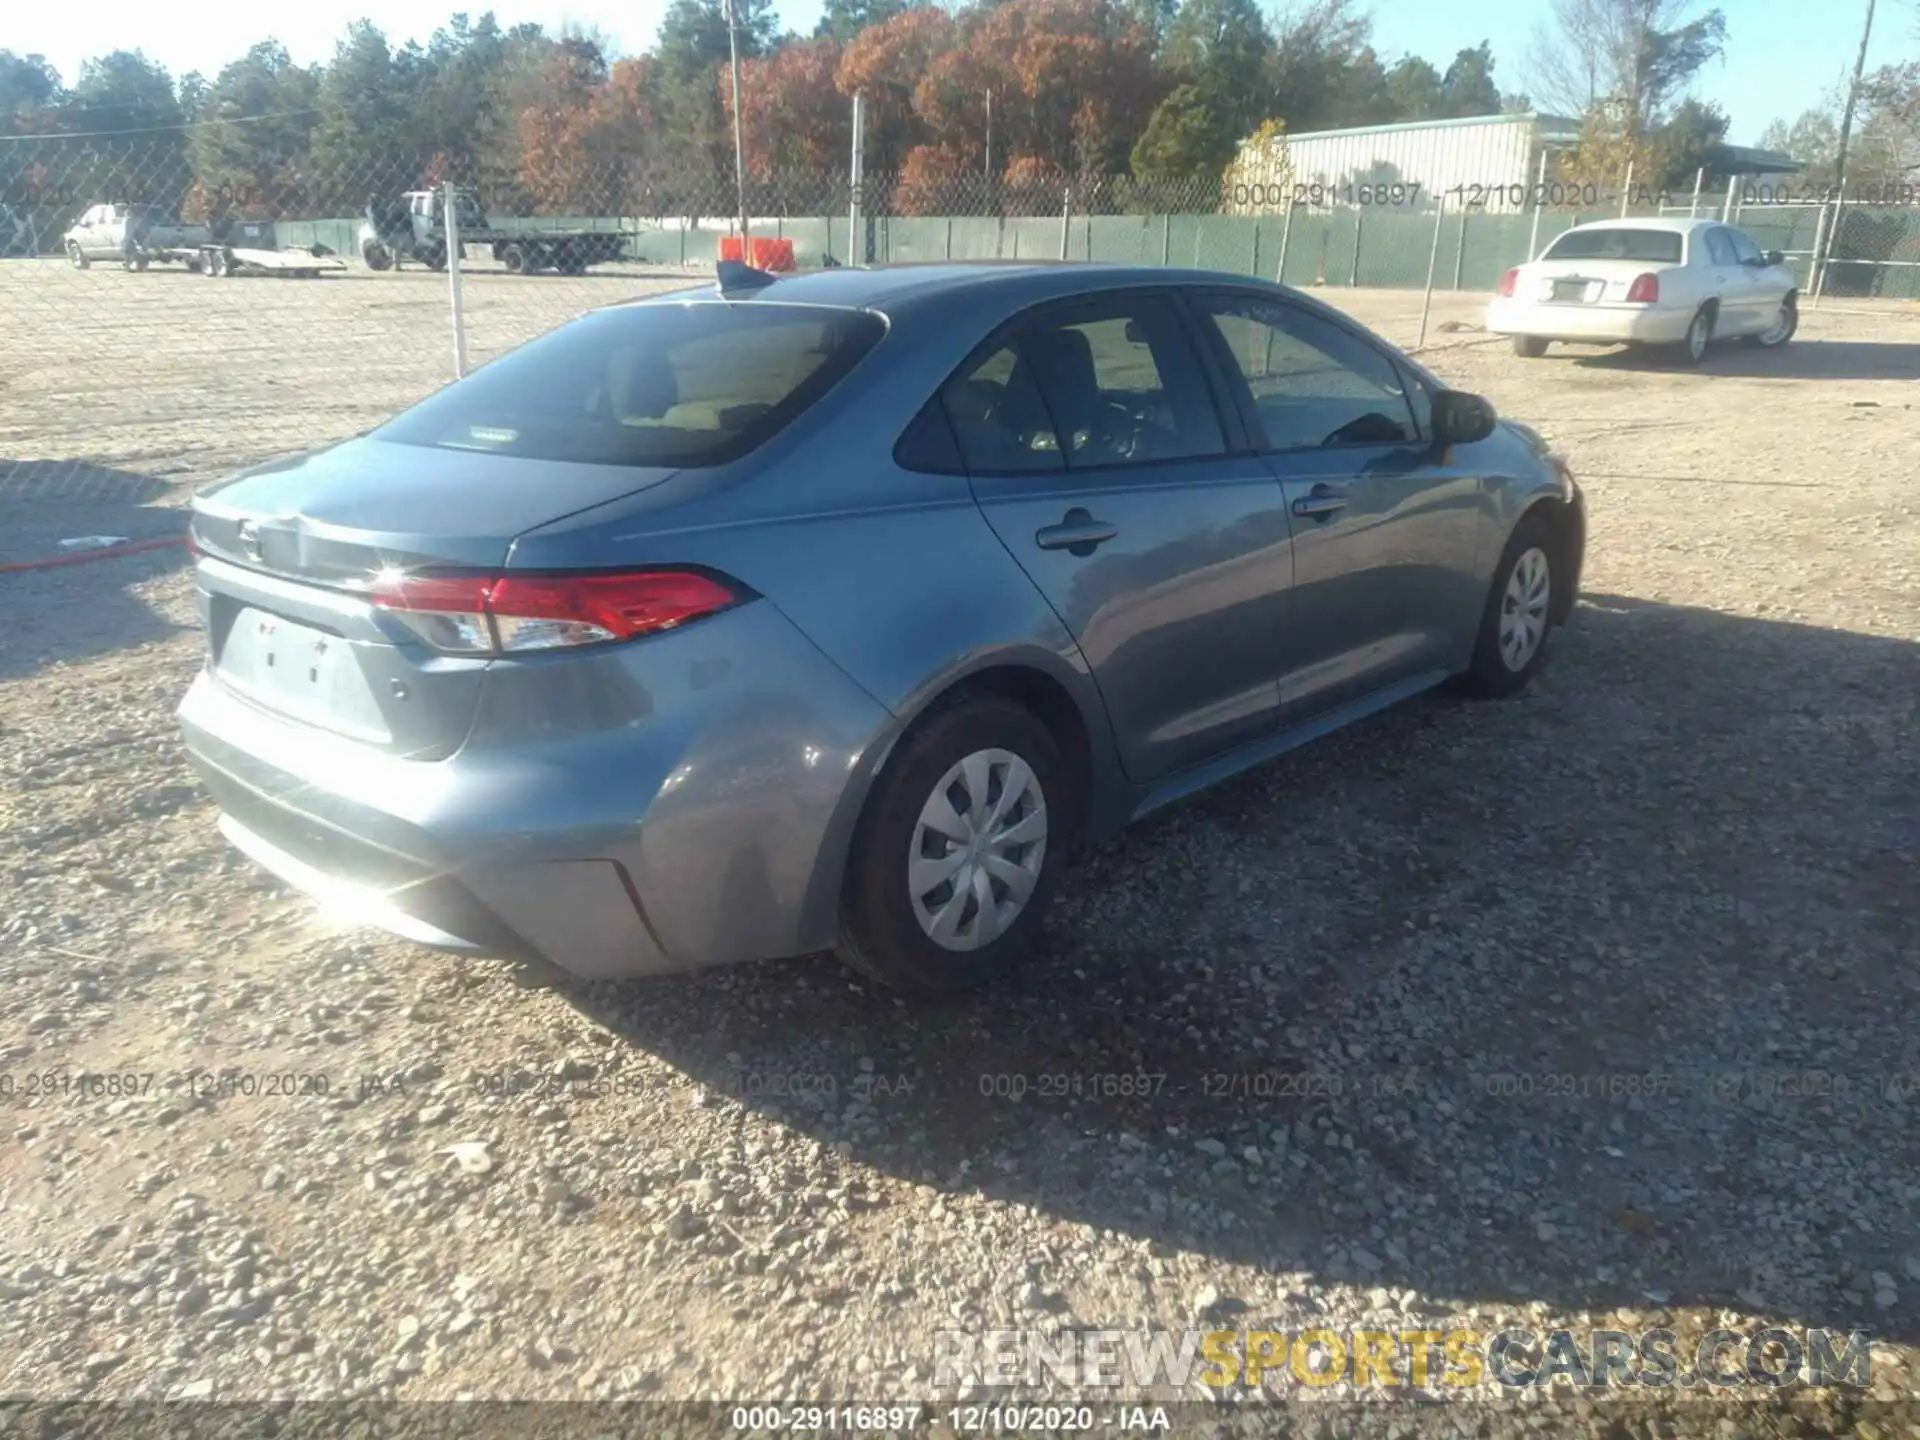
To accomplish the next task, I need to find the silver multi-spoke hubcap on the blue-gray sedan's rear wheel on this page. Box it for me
[906,751,1046,950]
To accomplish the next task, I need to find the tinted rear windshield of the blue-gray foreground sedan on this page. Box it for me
[374,300,885,467]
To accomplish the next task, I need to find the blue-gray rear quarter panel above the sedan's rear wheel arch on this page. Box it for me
[511,289,1127,937]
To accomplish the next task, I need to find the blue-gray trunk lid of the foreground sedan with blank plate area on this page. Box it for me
[194,440,674,760]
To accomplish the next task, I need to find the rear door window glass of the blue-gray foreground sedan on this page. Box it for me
[941,296,1227,472]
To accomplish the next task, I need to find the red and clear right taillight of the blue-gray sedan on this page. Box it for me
[372,570,739,655]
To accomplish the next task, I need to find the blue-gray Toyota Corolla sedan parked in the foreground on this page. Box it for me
[180,265,1586,993]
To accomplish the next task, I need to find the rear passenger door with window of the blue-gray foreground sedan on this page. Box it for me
[941,292,1292,781]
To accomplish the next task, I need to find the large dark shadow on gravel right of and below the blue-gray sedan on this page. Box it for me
[545,595,1920,1340]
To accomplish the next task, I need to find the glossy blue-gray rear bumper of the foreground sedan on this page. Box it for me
[179,603,893,977]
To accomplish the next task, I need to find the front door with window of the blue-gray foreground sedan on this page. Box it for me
[1194,292,1486,724]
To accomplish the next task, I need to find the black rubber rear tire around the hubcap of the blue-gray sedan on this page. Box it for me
[835,697,1079,996]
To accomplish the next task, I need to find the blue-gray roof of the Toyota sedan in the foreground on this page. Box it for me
[628,259,1297,311]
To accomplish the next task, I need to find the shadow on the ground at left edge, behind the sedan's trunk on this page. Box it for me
[0,459,192,682]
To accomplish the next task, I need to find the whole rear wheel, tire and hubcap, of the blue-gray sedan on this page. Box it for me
[835,699,1073,995]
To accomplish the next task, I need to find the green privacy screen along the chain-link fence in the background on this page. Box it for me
[276,205,1920,300]
